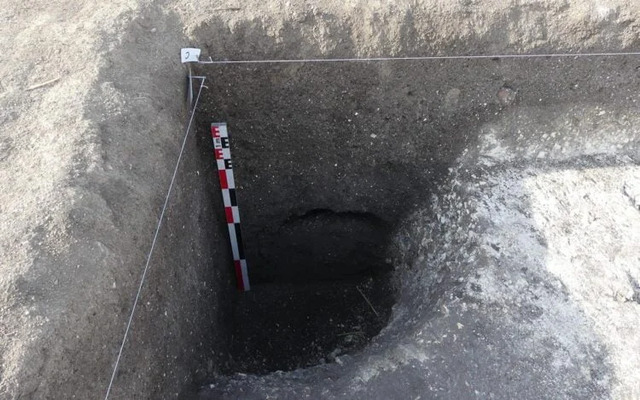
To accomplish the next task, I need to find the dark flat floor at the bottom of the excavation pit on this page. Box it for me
[223,274,394,375]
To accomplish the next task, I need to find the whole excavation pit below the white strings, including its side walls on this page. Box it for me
[89,14,637,399]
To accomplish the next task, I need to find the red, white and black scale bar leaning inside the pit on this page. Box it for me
[211,122,250,291]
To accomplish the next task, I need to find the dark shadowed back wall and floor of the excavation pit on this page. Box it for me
[189,54,640,375]
